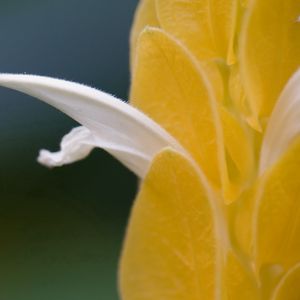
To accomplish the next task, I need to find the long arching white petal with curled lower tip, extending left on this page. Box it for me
[0,74,185,177]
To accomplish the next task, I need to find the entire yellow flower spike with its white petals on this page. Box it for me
[0,0,300,300]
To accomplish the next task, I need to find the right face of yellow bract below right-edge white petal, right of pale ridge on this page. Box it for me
[253,138,300,269]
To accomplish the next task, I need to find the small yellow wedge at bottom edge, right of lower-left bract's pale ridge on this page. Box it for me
[223,251,261,300]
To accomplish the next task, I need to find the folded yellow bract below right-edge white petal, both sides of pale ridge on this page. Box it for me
[233,139,300,288]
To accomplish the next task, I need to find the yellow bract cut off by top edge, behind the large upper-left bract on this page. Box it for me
[156,0,238,63]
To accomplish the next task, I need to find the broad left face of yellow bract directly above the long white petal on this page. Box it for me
[130,28,225,186]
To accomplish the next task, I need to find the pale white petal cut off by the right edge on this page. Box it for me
[260,70,300,174]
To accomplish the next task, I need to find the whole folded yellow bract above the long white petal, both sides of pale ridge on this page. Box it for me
[130,28,255,202]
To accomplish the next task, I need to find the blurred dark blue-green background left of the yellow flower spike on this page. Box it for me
[0,0,137,300]
